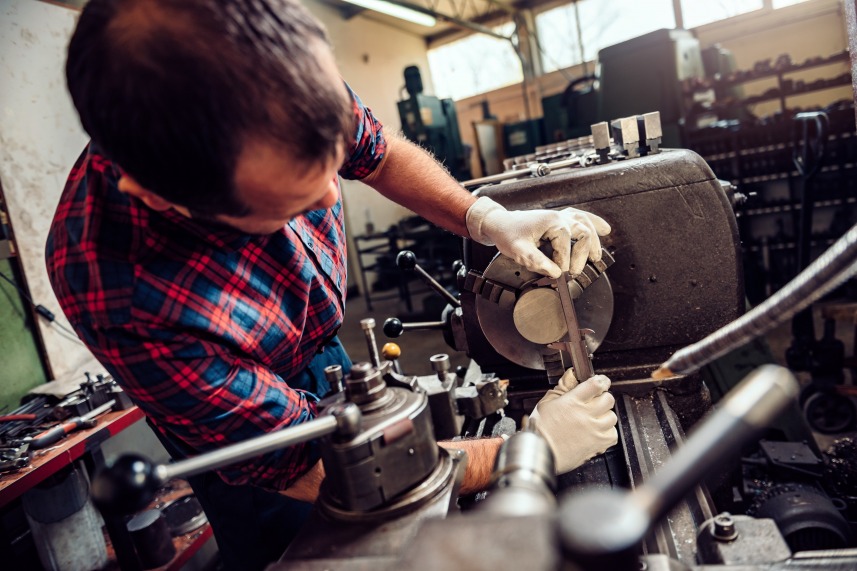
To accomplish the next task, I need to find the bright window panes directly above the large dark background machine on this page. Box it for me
[536,0,675,72]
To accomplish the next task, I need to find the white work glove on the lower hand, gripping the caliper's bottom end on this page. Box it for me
[530,369,619,474]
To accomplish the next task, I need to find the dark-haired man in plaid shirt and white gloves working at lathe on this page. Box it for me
[47,0,616,569]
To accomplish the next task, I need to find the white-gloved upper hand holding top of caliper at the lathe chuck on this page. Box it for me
[465,196,610,278]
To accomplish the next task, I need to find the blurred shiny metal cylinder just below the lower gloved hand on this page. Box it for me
[479,431,556,517]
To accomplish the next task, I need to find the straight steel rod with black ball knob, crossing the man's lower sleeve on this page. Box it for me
[155,416,340,482]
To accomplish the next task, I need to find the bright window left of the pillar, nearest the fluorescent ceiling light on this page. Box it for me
[428,22,524,99]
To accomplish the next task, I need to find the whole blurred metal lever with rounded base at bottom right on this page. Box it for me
[559,365,799,571]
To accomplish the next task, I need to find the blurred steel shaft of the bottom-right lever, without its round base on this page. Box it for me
[631,365,799,522]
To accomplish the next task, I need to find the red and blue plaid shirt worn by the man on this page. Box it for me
[46,90,386,490]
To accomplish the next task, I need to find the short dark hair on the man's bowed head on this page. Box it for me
[66,0,354,215]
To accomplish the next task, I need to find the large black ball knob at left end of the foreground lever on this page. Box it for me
[92,454,164,515]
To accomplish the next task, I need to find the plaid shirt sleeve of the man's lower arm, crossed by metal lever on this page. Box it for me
[77,325,320,491]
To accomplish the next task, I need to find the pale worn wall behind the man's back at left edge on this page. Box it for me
[0,0,101,380]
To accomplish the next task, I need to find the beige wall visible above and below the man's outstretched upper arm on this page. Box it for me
[304,0,433,294]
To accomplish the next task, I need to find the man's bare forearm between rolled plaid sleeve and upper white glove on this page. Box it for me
[362,135,476,237]
